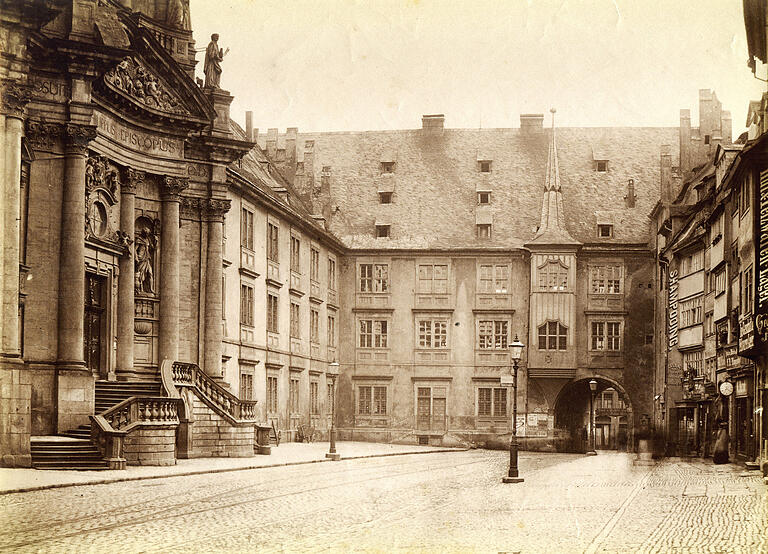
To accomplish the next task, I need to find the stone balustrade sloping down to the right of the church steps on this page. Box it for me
[160,362,256,423]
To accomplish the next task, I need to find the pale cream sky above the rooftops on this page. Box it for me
[190,0,765,133]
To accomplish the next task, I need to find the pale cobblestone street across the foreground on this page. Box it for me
[0,450,768,553]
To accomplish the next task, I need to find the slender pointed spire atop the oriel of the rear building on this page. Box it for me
[530,108,579,244]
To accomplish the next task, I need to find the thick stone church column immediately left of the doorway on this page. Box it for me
[57,123,96,369]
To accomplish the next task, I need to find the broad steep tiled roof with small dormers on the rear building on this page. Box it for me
[260,127,678,249]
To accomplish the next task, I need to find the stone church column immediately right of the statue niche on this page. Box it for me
[159,177,188,363]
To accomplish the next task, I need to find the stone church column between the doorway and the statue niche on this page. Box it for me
[116,168,144,375]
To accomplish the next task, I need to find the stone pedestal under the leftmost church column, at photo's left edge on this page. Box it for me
[0,360,32,467]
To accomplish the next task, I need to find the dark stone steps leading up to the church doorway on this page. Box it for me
[31,381,161,471]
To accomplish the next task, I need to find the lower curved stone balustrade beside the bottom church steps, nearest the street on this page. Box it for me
[91,396,181,469]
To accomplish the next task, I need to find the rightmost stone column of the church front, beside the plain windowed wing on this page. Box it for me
[204,198,231,379]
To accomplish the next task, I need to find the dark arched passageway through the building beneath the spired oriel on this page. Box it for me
[555,377,632,452]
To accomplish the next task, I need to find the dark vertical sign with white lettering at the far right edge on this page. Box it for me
[754,170,768,347]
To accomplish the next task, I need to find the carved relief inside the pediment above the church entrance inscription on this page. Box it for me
[104,56,189,115]
